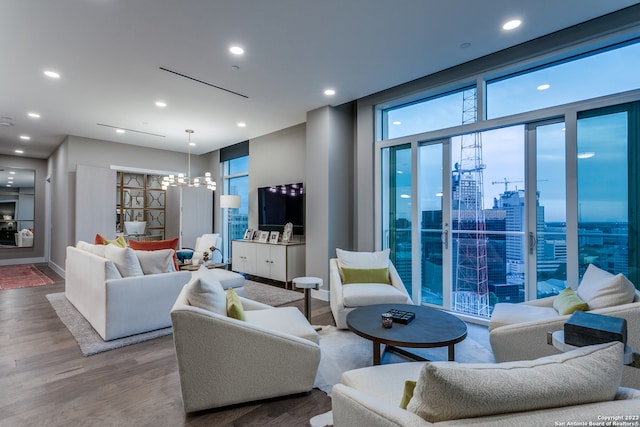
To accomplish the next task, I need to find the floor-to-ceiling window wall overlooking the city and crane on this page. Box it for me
[378,36,640,319]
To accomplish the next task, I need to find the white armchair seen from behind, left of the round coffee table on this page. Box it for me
[171,284,320,412]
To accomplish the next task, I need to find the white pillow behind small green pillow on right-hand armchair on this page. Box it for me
[576,264,636,310]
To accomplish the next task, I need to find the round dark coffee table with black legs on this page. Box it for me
[347,304,467,365]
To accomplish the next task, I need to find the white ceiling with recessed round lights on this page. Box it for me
[0,0,637,158]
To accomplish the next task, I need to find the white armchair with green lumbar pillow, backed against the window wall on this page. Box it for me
[329,249,412,329]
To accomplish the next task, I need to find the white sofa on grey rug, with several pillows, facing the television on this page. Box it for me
[65,242,191,341]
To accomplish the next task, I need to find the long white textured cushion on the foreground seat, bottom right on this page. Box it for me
[407,342,624,423]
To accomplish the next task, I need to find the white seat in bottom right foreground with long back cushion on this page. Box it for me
[331,343,640,427]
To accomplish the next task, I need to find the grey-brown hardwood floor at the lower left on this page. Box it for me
[0,266,333,427]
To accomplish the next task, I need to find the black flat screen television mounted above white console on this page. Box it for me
[258,183,304,235]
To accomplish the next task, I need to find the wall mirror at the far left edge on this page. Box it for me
[0,166,36,249]
